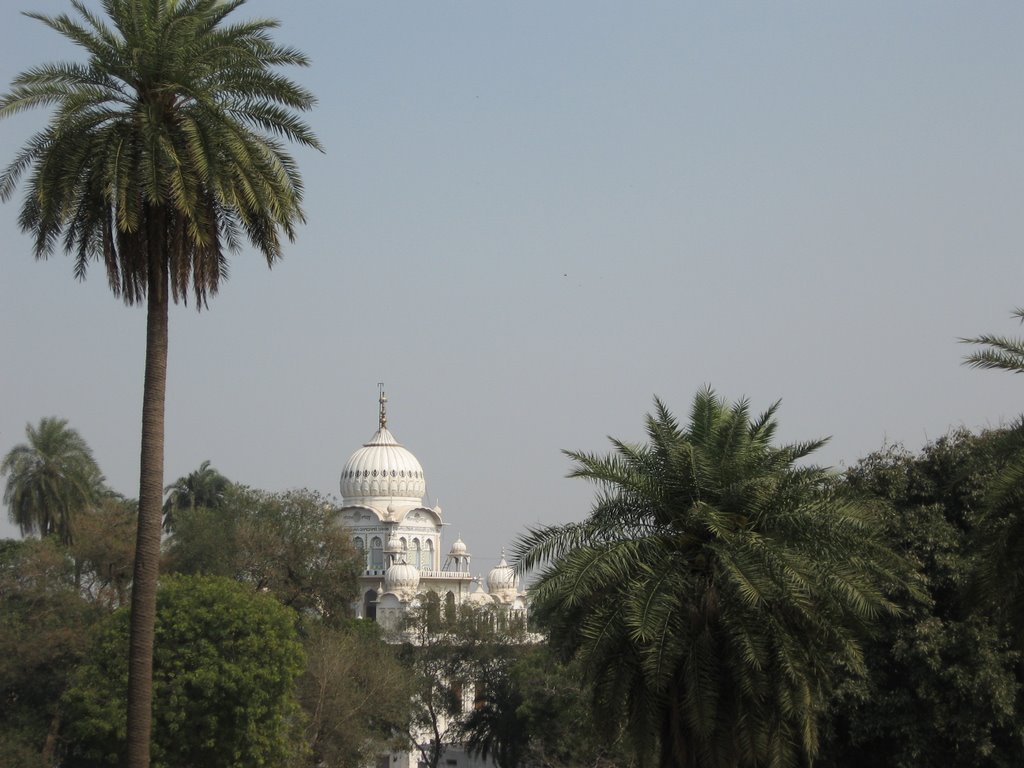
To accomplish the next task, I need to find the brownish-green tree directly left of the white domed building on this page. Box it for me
[168,486,361,624]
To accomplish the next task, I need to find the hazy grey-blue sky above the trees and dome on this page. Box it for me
[0,0,1024,572]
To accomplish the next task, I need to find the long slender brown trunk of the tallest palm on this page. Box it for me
[125,208,169,768]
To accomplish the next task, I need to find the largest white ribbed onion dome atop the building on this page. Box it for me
[341,426,427,504]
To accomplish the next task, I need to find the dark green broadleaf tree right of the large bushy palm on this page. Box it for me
[818,430,1024,768]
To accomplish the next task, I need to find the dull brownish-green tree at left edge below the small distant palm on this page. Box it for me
[0,538,104,768]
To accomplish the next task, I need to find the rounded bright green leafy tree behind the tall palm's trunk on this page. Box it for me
[63,577,304,768]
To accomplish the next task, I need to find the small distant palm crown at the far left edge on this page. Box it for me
[0,417,103,546]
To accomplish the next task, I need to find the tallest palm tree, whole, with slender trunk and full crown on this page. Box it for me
[0,0,319,768]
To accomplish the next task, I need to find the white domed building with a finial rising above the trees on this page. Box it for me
[338,389,526,629]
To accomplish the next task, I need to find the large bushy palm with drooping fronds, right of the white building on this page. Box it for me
[515,389,906,768]
